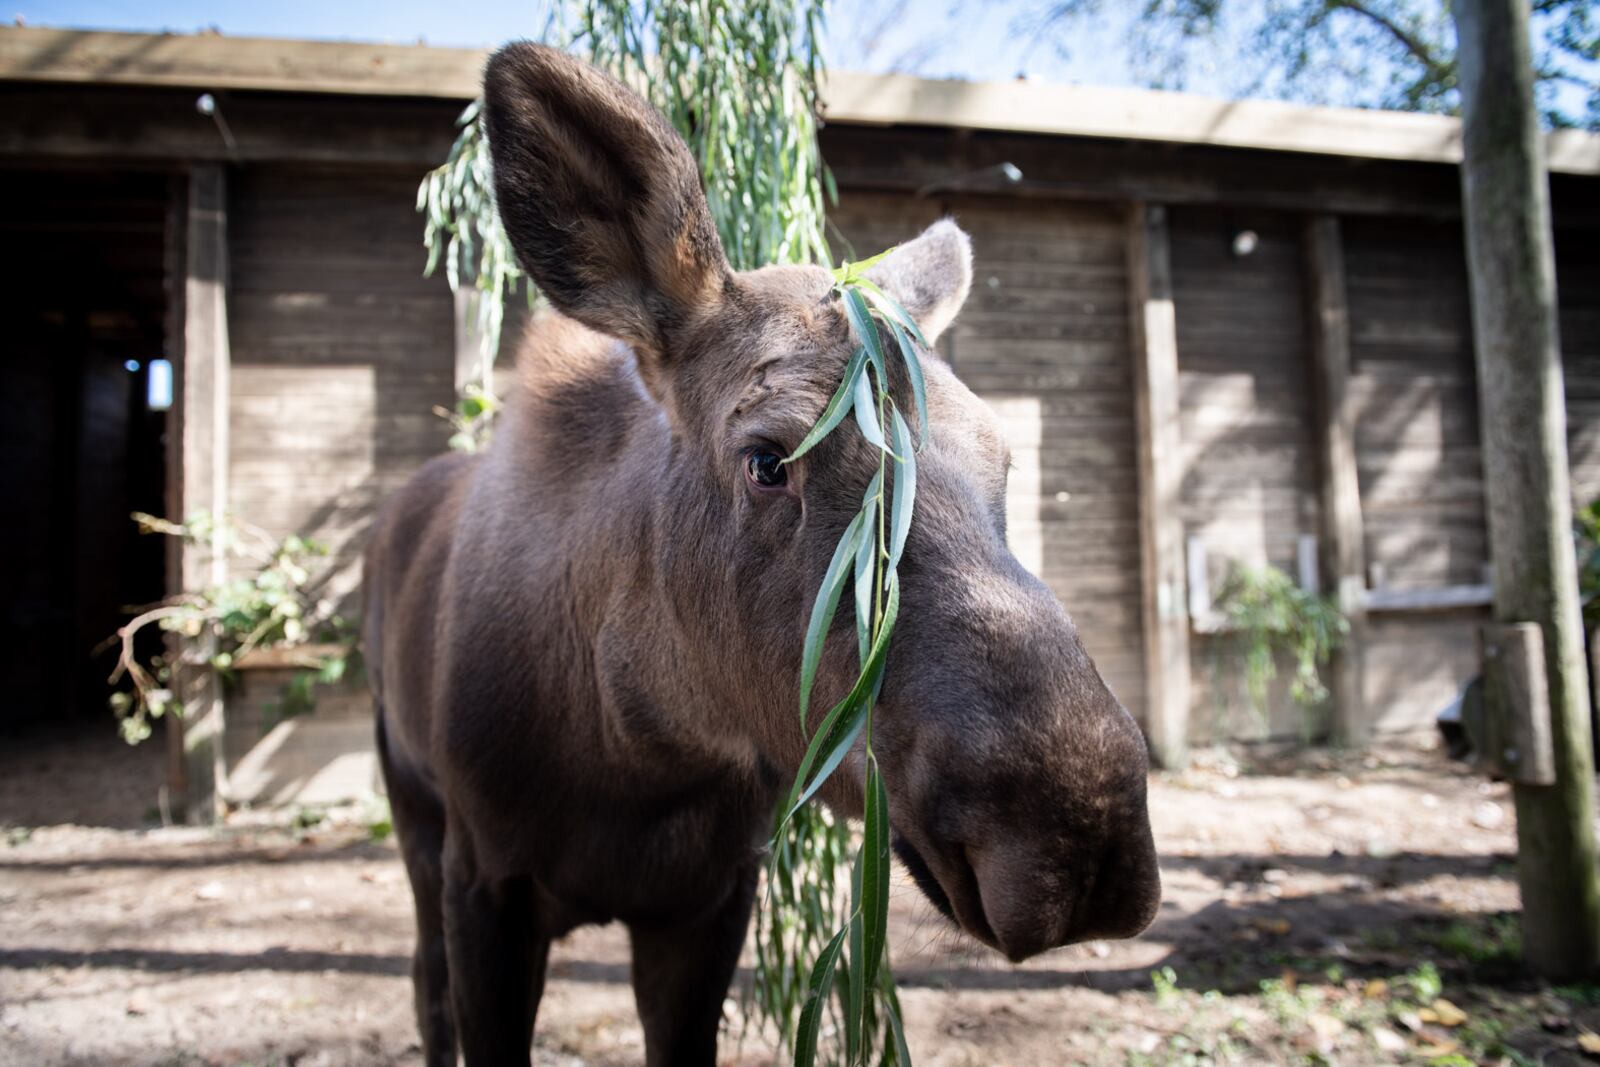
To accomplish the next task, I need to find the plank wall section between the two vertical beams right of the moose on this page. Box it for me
[1170,208,1317,741]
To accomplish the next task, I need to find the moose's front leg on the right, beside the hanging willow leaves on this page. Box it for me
[627,864,757,1067]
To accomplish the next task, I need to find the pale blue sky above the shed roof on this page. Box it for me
[10,0,1205,88]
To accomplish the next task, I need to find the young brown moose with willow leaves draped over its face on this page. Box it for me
[366,45,1160,1064]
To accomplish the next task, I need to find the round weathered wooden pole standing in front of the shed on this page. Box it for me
[1453,0,1600,981]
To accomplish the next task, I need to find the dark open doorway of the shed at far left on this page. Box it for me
[0,170,174,731]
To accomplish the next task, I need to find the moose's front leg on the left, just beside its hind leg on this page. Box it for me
[445,845,550,1067]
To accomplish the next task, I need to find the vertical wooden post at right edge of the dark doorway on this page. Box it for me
[173,165,229,822]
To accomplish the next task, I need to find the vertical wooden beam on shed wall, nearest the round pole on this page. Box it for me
[1306,214,1371,745]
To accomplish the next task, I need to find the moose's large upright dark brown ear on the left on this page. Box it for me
[483,42,730,362]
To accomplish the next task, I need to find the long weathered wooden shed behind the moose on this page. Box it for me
[0,29,1600,795]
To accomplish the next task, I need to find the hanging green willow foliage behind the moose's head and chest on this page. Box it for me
[418,0,883,1062]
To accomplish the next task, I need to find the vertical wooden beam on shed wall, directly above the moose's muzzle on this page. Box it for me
[1128,203,1189,768]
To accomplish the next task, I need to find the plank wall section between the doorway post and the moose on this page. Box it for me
[229,166,454,597]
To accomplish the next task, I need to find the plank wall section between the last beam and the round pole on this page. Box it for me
[1342,219,1488,731]
